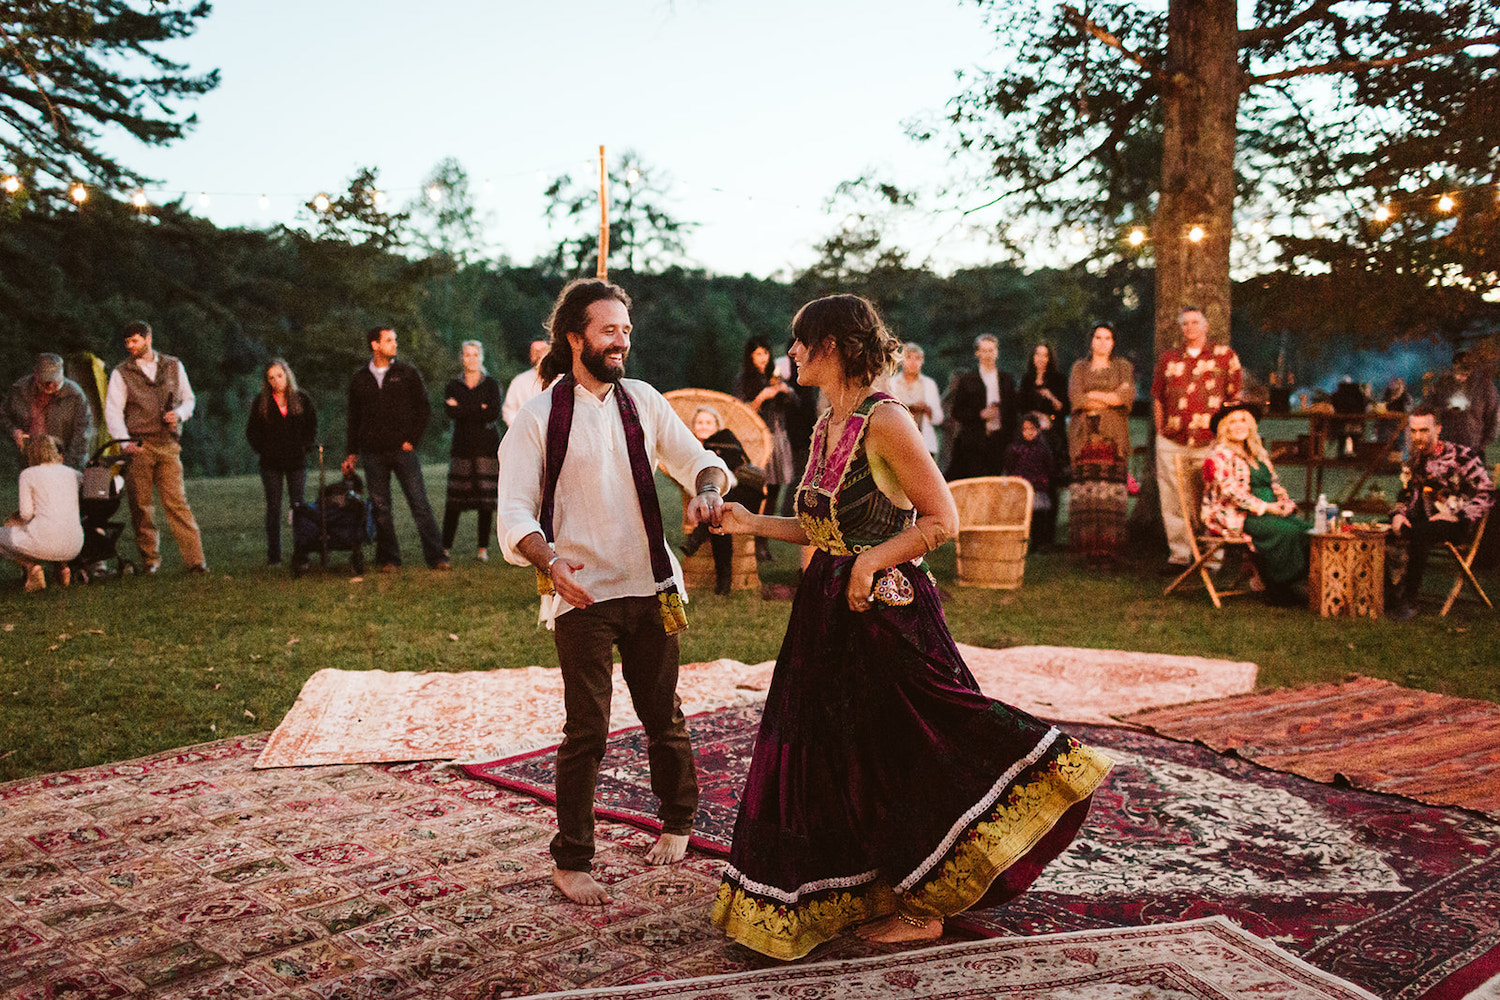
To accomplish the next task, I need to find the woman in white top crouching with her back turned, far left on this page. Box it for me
[0,435,84,591]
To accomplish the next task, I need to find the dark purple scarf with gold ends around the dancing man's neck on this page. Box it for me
[537,375,687,636]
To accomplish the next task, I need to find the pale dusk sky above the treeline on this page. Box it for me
[110,0,993,276]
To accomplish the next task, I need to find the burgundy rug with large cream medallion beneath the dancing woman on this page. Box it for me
[470,708,1500,1000]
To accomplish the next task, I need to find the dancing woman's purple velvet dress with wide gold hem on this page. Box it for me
[711,393,1110,960]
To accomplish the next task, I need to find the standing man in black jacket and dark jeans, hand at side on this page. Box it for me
[342,327,449,573]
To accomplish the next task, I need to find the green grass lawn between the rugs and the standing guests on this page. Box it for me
[0,452,1500,781]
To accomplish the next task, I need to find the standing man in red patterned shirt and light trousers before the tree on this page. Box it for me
[1151,306,1242,573]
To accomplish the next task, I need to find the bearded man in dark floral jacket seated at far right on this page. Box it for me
[1386,405,1494,622]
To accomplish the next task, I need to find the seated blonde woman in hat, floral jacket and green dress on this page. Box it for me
[1202,403,1311,606]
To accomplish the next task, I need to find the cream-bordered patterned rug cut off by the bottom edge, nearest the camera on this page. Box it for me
[522,916,1376,1000]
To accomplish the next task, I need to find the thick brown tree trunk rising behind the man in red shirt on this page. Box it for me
[1152,0,1244,354]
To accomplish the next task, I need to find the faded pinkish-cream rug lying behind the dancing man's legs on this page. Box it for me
[255,660,771,768]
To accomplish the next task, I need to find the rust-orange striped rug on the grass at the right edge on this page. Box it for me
[1127,678,1500,816]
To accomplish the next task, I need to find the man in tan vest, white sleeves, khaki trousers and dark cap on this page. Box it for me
[104,319,209,573]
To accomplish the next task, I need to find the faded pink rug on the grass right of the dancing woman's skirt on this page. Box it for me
[959,643,1256,726]
